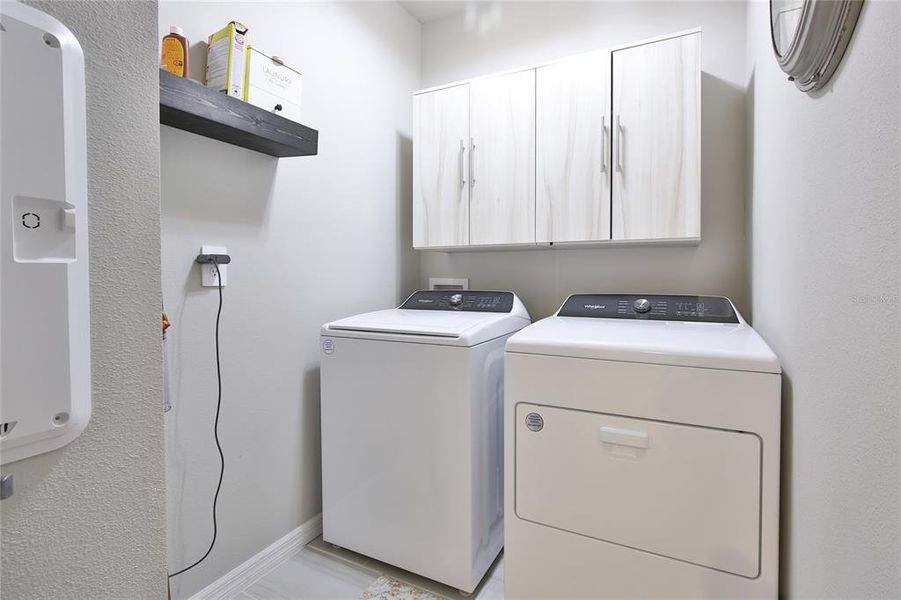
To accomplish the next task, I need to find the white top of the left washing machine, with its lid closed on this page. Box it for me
[322,291,531,346]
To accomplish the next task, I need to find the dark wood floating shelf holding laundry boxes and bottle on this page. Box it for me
[160,69,319,157]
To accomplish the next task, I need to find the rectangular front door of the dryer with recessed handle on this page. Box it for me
[515,403,761,578]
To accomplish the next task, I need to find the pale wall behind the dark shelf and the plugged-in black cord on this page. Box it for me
[159,2,420,598]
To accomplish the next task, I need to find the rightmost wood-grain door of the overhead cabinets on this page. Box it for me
[613,34,701,240]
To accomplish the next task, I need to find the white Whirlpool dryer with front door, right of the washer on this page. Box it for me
[504,294,781,598]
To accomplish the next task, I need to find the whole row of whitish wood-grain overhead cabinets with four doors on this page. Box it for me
[413,31,701,249]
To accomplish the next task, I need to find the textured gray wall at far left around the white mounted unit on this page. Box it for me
[0,2,166,599]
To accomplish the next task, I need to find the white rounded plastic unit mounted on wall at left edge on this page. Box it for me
[0,1,91,463]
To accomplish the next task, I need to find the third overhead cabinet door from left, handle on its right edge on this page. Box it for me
[535,52,611,242]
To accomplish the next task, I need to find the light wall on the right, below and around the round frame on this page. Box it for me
[748,0,901,598]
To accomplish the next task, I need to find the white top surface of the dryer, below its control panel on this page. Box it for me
[507,304,782,373]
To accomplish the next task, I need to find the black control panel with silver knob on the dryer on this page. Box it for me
[557,294,738,323]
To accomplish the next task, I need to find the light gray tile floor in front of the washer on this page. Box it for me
[237,537,504,600]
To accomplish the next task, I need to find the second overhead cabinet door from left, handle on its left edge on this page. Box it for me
[469,69,535,245]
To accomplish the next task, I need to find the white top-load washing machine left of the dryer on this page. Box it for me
[321,290,530,592]
